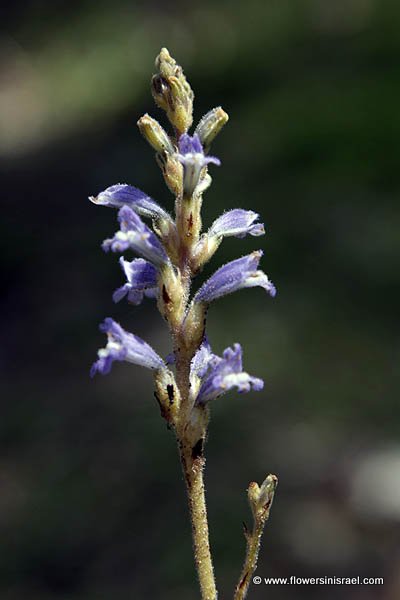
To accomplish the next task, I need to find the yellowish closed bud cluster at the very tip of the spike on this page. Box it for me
[151,48,194,135]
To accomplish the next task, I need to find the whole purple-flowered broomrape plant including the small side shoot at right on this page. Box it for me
[90,48,277,600]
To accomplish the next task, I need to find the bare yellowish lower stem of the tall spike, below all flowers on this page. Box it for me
[180,441,217,600]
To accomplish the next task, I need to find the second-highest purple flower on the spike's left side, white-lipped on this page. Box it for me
[102,206,168,266]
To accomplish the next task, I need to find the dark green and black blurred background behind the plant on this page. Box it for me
[0,0,400,600]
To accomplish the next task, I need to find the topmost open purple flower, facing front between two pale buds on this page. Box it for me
[176,133,221,196]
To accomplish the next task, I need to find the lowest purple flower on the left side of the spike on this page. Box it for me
[90,318,165,377]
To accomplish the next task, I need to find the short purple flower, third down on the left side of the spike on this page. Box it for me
[113,256,158,304]
